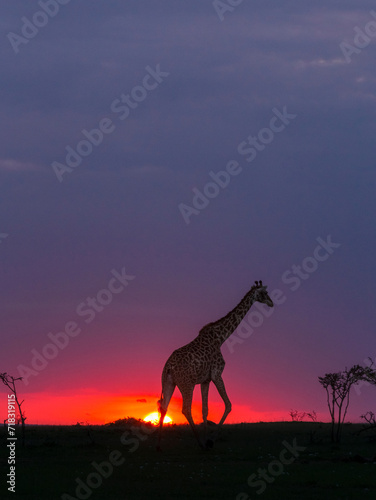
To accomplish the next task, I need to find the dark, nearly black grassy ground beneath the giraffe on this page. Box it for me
[0,421,376,500]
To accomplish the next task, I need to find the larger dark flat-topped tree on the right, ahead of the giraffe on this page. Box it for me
[319,363,376,443]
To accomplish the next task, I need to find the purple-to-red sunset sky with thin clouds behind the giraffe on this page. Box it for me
[0,0,376,424]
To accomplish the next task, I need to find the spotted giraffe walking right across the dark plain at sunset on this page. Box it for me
[157,281,273,449]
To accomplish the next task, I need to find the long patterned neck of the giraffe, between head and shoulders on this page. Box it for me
[200,289,255,345]
